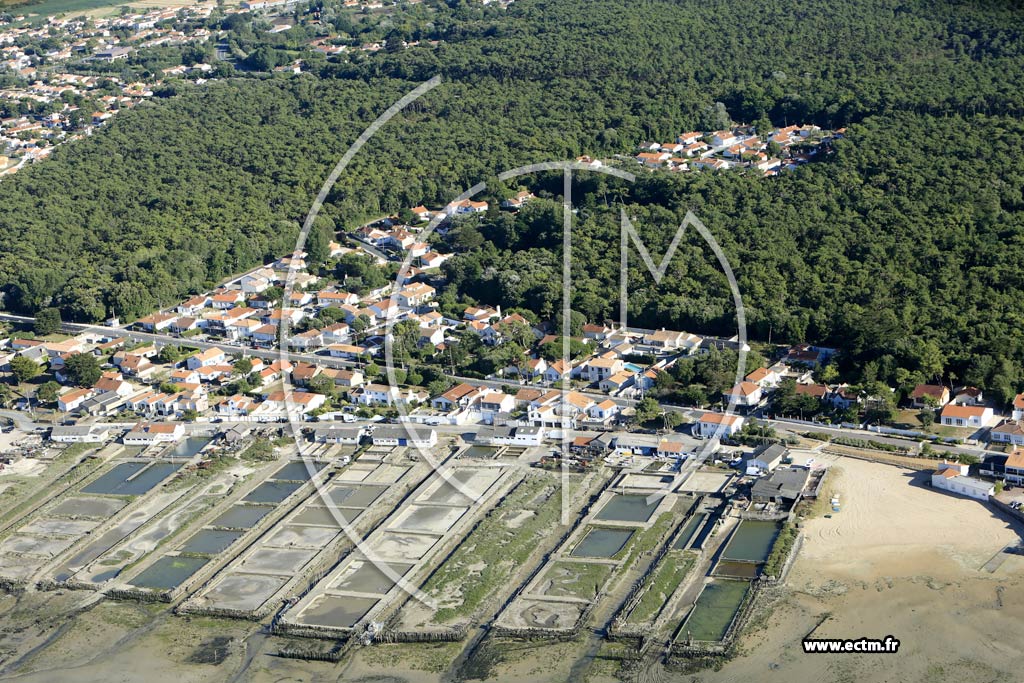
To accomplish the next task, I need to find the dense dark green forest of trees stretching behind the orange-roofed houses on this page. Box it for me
[0,0,1024,397]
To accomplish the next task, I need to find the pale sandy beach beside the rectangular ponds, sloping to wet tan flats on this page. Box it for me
[700,457,1024,683]
